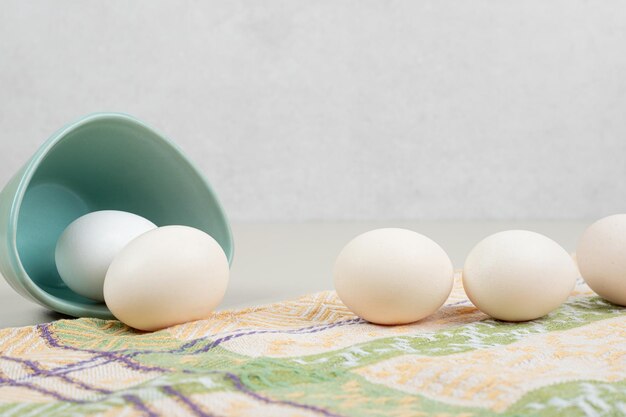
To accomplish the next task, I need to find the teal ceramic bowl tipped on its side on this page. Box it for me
[0,113,233,318]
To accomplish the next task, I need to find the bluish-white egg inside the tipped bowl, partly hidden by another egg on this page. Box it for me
[54,210,157,301]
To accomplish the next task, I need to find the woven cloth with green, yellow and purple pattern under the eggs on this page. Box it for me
[0,277,626,417]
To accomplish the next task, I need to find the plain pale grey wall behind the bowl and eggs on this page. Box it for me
[0,0,626,221]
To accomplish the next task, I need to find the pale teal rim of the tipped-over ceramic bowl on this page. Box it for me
[7,112,235,319]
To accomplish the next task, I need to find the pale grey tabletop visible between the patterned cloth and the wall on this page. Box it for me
[0,221,591,328]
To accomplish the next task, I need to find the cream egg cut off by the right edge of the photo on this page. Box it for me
[576,214,626,306]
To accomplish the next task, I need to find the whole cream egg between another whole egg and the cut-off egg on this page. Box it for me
[463,230,578,321]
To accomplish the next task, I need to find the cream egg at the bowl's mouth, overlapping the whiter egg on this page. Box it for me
[104,226,229,331]
